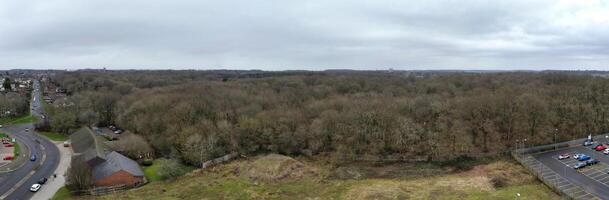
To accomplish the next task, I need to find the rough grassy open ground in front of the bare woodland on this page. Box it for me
[65,157,560,200]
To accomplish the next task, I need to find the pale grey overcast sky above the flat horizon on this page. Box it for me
[0,0,609,70]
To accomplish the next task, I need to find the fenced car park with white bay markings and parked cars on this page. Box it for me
[525,146,609,200]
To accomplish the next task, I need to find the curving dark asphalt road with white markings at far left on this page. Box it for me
[0,81,60,200]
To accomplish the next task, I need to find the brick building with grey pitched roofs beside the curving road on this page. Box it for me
[70,127,144,186]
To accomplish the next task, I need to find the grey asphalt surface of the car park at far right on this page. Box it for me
[534,146,609,200]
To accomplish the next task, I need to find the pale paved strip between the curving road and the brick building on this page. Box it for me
[32,142,73,200]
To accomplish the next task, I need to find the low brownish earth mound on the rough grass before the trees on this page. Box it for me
[239,154,318,182]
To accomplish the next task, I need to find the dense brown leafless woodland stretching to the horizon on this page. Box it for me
[40,71,609,165]
